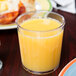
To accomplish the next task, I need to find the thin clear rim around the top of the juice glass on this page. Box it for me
[15,10,65,32]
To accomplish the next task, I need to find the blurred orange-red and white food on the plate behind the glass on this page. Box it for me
[0,0,35,24]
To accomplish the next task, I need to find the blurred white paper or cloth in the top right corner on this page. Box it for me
[51,0,76,14]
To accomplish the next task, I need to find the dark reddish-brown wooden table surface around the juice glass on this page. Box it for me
[0,10,76,76]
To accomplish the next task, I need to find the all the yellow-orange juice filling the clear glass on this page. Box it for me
[18,18,63,72]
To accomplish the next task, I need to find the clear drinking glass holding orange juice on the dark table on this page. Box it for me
[16,11,65,75]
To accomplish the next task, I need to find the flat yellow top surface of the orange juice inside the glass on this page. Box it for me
[21,18,61,31]
